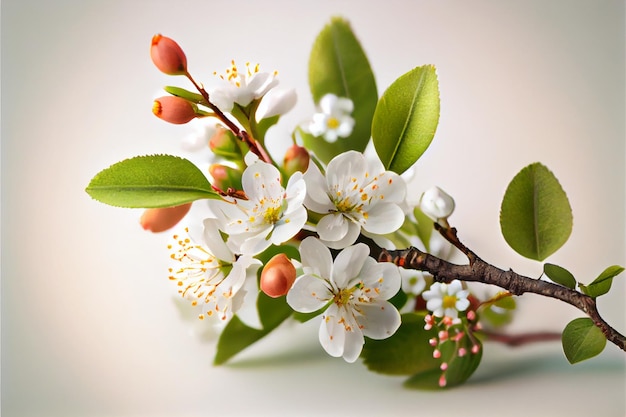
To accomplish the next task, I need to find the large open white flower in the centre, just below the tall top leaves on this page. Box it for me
[304,151,406,249]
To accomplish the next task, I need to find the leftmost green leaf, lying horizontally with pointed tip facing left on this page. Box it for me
[85,155,220,208]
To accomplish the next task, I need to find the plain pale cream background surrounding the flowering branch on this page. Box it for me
[2,0,626,417]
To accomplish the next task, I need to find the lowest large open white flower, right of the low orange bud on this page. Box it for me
[287,237,400,362]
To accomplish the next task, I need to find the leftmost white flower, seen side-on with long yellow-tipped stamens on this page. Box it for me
[170,219,261,328]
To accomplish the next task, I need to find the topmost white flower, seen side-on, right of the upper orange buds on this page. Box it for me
[210,61,278,112]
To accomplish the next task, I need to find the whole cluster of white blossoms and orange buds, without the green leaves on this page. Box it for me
[146,35,469,362]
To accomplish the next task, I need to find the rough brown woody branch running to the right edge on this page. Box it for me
[372,223,626,351]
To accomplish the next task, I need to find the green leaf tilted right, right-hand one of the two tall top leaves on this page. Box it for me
[372,65,439,174]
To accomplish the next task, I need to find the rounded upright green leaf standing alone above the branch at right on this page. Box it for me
[500,162,573,261]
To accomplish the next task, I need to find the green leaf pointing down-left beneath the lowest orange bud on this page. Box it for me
[213,293,293,365]
